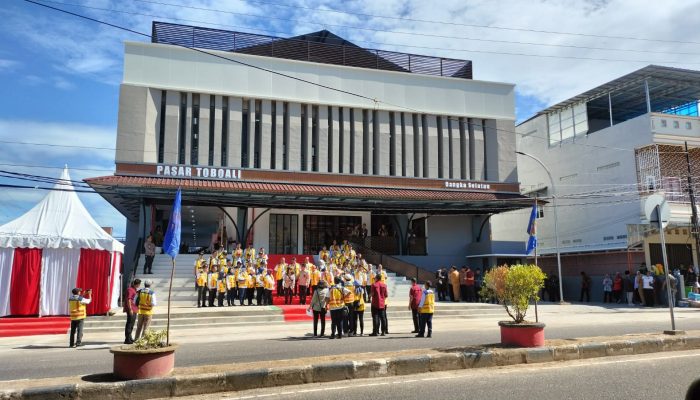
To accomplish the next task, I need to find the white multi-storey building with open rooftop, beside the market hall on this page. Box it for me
[494,65,700,299]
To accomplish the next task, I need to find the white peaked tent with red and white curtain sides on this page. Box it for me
[0,168,124,316]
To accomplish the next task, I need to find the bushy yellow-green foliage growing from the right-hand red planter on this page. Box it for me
[481,264,546,324]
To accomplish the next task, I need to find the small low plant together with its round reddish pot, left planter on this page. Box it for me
[110,329,177,379]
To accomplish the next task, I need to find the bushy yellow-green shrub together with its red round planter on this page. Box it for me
[482,264,545,347]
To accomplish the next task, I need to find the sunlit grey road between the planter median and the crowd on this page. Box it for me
[0,306,700,380]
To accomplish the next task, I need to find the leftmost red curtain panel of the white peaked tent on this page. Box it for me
[10,248,42,315]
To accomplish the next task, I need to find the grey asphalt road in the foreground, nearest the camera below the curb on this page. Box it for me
[172,350,700,400]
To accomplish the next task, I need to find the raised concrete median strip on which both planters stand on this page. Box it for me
[0,330,700,400]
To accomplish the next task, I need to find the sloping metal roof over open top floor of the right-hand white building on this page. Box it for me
[524,65,700,121]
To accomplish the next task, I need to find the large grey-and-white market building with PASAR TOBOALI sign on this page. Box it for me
[87,22,529,284]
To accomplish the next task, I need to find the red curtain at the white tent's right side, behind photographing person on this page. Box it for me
[77,249,112,315]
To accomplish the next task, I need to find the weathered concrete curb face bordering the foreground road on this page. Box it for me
[0,336,700,400]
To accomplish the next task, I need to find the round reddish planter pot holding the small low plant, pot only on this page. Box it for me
[109,344,178,380]
